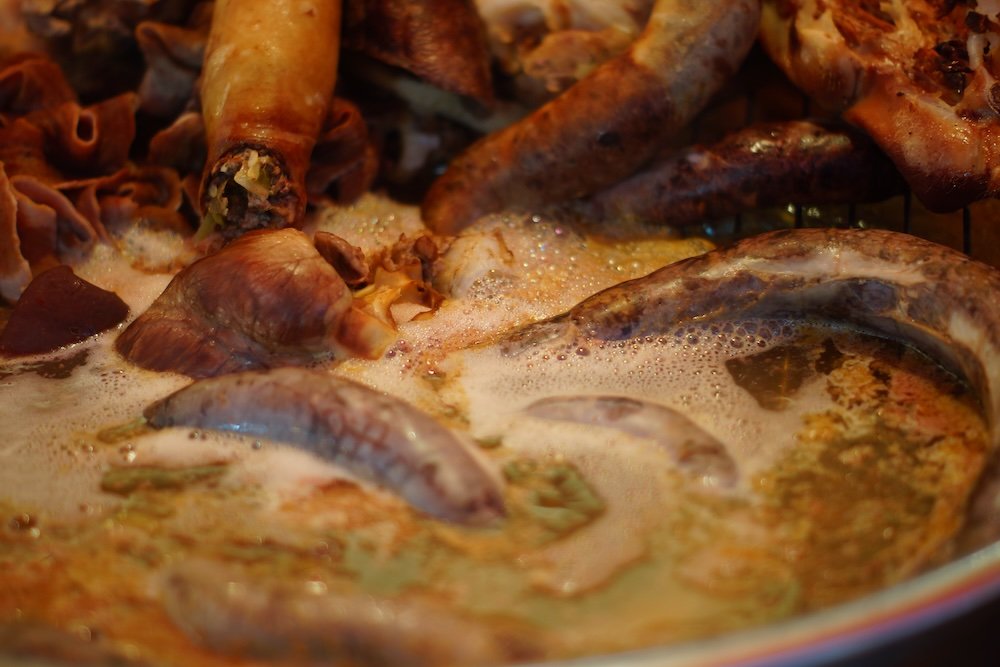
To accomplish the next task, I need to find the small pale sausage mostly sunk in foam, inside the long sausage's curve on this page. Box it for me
[525,396,738,486]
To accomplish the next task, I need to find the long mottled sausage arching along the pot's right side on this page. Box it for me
[503,229,1000,446]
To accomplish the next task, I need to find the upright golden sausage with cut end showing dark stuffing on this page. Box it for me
[200,0,340,238]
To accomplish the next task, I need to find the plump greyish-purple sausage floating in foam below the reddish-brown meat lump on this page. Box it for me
[145,368,504,525]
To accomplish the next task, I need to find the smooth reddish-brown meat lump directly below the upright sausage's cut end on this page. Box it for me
[115,229,365,377]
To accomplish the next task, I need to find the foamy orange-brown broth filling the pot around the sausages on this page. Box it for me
[0,198,986,664]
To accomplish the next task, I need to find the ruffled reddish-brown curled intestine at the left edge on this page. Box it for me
[0,55,195,302]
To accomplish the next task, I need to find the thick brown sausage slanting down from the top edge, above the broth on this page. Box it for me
[422,0,760,233]
